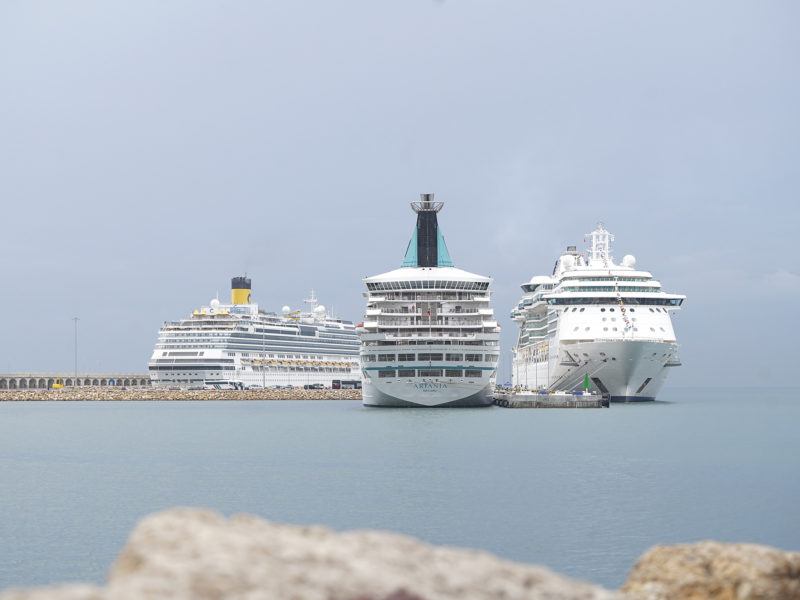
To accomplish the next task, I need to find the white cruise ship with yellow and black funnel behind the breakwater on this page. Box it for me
[149,277,359,389]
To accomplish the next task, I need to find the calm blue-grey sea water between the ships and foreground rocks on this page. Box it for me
[0,387,800,589]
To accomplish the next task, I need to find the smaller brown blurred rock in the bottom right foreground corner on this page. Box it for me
[622,542,800,600]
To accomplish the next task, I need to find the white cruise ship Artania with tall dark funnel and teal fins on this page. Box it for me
[357,194,500,407]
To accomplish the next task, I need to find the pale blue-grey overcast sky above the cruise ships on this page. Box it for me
[0,0,800,386]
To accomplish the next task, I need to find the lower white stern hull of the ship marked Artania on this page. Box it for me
[361,380,494,408]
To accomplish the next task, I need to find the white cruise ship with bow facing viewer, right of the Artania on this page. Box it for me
[511,223,686,402]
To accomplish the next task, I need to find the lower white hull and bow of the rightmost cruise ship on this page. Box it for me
[514,340,679,402]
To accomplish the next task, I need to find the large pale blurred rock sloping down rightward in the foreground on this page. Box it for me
[0,509,614,600]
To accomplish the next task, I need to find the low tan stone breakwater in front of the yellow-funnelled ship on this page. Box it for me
[0,387,361,402]
